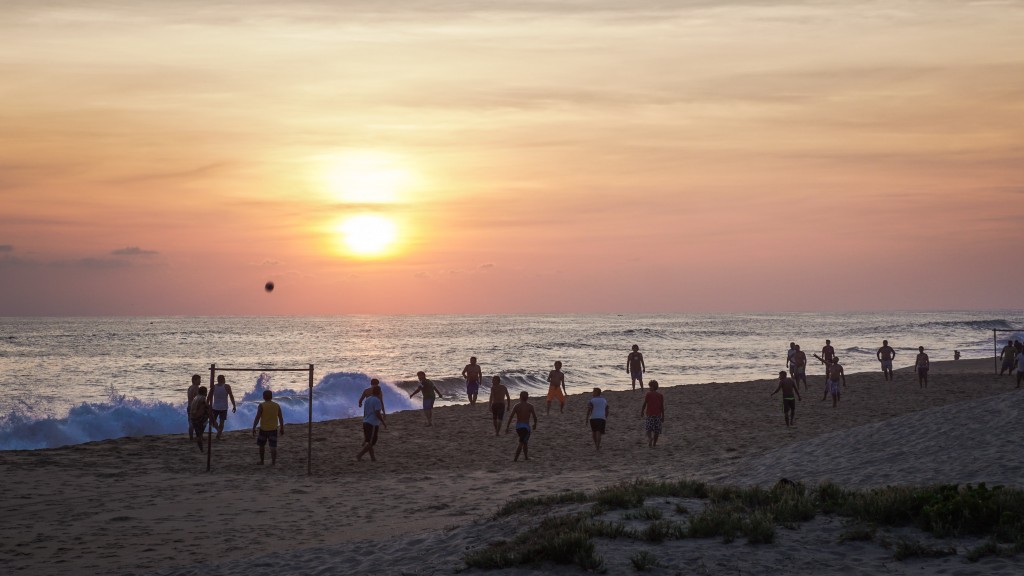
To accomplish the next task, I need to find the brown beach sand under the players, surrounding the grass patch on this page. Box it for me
[0,360,1024,575]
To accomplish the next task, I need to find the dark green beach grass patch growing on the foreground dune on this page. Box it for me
[465,480,1024,571]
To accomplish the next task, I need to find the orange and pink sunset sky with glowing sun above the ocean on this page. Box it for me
[0,0,1024,316]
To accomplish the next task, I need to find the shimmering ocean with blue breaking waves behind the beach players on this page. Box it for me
[0,311,1024,450]
